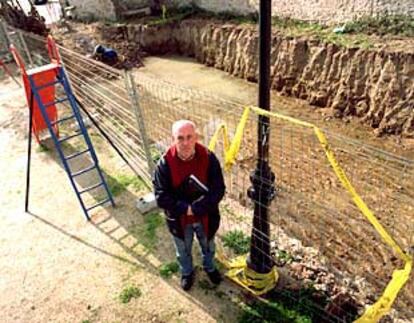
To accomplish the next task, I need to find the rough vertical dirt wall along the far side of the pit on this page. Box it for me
[123,20,414,137]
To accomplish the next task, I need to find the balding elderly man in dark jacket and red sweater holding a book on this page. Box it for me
[153,120,225,290]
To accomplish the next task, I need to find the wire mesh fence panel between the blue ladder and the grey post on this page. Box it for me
[61,48,151,185]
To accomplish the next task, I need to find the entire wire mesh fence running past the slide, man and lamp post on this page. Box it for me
[6,27,414,321]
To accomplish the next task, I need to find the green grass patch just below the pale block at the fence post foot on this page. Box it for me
[131,212,164,250]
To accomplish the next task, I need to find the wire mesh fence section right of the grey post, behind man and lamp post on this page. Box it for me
[137,69,414,315]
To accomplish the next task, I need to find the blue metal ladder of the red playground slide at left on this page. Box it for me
[27,63,115,221]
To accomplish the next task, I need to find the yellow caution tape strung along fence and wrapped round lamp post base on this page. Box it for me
[209,107,413,323]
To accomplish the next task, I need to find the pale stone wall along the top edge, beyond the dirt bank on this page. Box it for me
[175,0,414,23]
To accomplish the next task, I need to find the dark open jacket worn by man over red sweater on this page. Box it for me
[153,147,225,239]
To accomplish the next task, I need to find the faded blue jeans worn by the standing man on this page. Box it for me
[174,222,216,276]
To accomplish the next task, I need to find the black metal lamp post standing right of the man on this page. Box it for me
[247,0,275,274]
